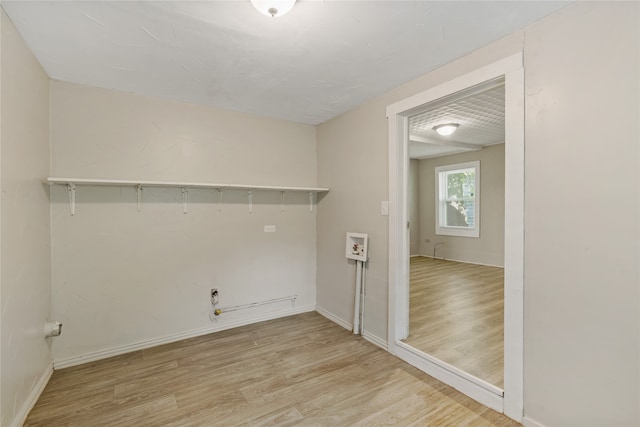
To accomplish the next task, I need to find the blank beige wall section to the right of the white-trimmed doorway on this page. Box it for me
[525,2,640,426]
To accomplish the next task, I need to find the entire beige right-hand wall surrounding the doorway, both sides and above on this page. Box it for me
[318,2,640,426]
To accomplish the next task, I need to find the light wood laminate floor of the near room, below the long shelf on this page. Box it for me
[25,313,519,427]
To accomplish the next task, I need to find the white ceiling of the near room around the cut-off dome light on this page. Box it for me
[2,0,570,124]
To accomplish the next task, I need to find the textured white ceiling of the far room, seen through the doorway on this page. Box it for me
[409,81,505,159]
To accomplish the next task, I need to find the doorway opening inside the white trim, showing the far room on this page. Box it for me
[402,78,505,389]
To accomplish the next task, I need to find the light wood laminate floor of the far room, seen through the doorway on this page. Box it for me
[405,257,504,388]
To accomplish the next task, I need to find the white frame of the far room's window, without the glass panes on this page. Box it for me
[435,160,480,238]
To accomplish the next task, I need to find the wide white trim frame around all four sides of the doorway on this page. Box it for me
[387,52,525,422]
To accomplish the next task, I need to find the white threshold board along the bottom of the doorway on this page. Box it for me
[396,342,504,413]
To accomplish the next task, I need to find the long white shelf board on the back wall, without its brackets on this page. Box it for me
[47,177,329,193]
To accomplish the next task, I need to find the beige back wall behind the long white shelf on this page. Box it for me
[51,82,316,366]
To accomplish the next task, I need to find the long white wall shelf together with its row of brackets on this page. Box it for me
[47,177,329,216]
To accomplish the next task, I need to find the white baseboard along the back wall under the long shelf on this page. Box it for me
[53,305,316,369]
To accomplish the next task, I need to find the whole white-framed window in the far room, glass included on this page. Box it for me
[436,161,480,237]
